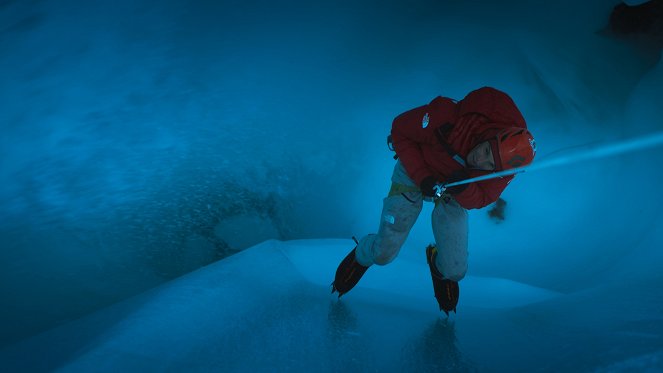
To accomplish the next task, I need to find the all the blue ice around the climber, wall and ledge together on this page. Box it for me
[0,0,663,371]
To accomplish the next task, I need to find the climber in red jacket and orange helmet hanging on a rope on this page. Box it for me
[332,87,536,315]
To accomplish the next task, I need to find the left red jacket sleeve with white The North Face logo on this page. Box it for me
[391,96,456,185]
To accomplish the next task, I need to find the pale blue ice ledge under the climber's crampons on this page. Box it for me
[0,240,663,372]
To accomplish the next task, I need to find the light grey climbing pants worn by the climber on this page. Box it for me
[356,161,468,281]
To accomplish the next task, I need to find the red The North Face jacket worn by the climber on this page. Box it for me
[391,87,527,209]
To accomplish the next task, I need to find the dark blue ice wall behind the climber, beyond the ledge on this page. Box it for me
[0,0,661,343]
